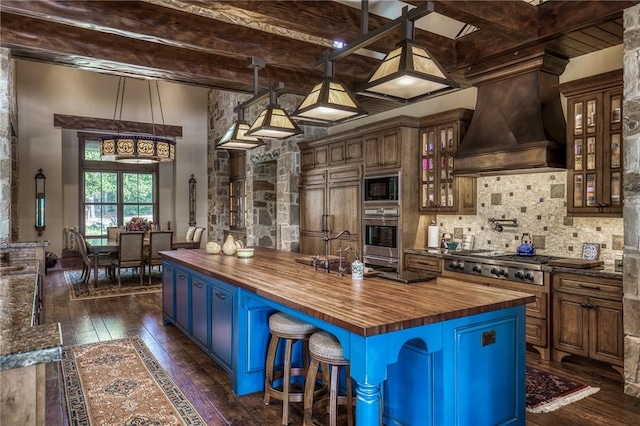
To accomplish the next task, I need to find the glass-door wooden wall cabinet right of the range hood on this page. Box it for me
[559,70,623,217]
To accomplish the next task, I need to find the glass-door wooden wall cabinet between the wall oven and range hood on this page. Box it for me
[418,109,477,214]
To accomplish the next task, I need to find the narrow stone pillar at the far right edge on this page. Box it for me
[622,5,640,398]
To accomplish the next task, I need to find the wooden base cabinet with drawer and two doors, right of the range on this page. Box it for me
[553,273,624,367]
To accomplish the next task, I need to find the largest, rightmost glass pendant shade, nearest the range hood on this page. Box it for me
[360,40,458,100]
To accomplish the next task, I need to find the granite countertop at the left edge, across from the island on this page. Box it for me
[0,262,62,370]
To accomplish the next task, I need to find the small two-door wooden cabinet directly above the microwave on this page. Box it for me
[363,129,402,172]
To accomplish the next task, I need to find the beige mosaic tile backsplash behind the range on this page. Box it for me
[437,171,624,265]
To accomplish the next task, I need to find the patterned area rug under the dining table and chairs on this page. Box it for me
[64,268,162,300]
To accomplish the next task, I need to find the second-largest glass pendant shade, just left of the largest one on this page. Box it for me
[293,77,367,122]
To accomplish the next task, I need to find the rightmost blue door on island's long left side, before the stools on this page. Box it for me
[211,284,233,369]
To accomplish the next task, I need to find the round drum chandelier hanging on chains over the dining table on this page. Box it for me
[99,77,176,164]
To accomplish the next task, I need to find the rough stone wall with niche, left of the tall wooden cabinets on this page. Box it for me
[208,90,327,251]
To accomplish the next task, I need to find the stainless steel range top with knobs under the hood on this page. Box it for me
[442,250,557,286]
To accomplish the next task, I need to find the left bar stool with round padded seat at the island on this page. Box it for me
[264,312,320,425]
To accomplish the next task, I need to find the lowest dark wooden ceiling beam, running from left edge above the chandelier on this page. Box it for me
[0,13,330,94]
